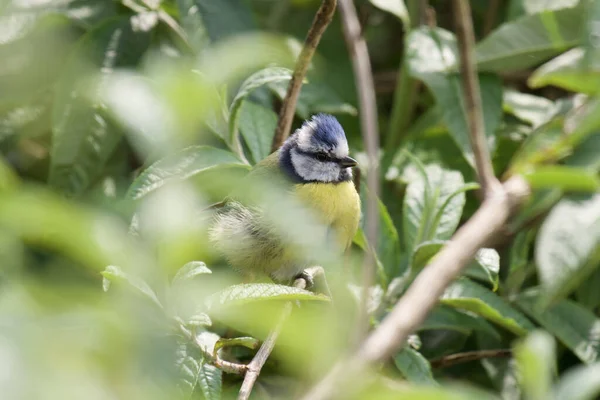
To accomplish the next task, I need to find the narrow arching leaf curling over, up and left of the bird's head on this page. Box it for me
[228,67,292,152]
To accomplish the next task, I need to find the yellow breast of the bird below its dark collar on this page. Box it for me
[295,181,360,248]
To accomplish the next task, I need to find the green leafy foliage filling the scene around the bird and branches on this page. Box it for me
[0,0,600,399]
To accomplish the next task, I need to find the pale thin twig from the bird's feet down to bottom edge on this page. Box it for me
[238,278,306,400]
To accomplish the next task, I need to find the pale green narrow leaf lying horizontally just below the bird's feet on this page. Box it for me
[207,283,329,308]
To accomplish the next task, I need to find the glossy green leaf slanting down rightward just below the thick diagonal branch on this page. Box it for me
[441,278,534,336]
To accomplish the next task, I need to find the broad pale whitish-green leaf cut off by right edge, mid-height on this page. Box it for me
[535,194,600,303]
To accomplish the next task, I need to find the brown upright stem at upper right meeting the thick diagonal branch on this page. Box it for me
[454,0,500,196]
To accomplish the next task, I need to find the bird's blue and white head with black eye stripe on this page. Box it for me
[280,114,356,183]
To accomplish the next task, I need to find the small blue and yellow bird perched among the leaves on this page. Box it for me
[209,114,360,283]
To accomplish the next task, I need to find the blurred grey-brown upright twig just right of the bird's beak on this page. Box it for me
[340,0,379,343]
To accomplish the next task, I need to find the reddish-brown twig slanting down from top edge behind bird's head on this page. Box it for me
[271,0,336,151]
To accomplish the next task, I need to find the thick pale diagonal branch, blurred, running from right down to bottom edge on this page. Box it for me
[304,176,529,400]
